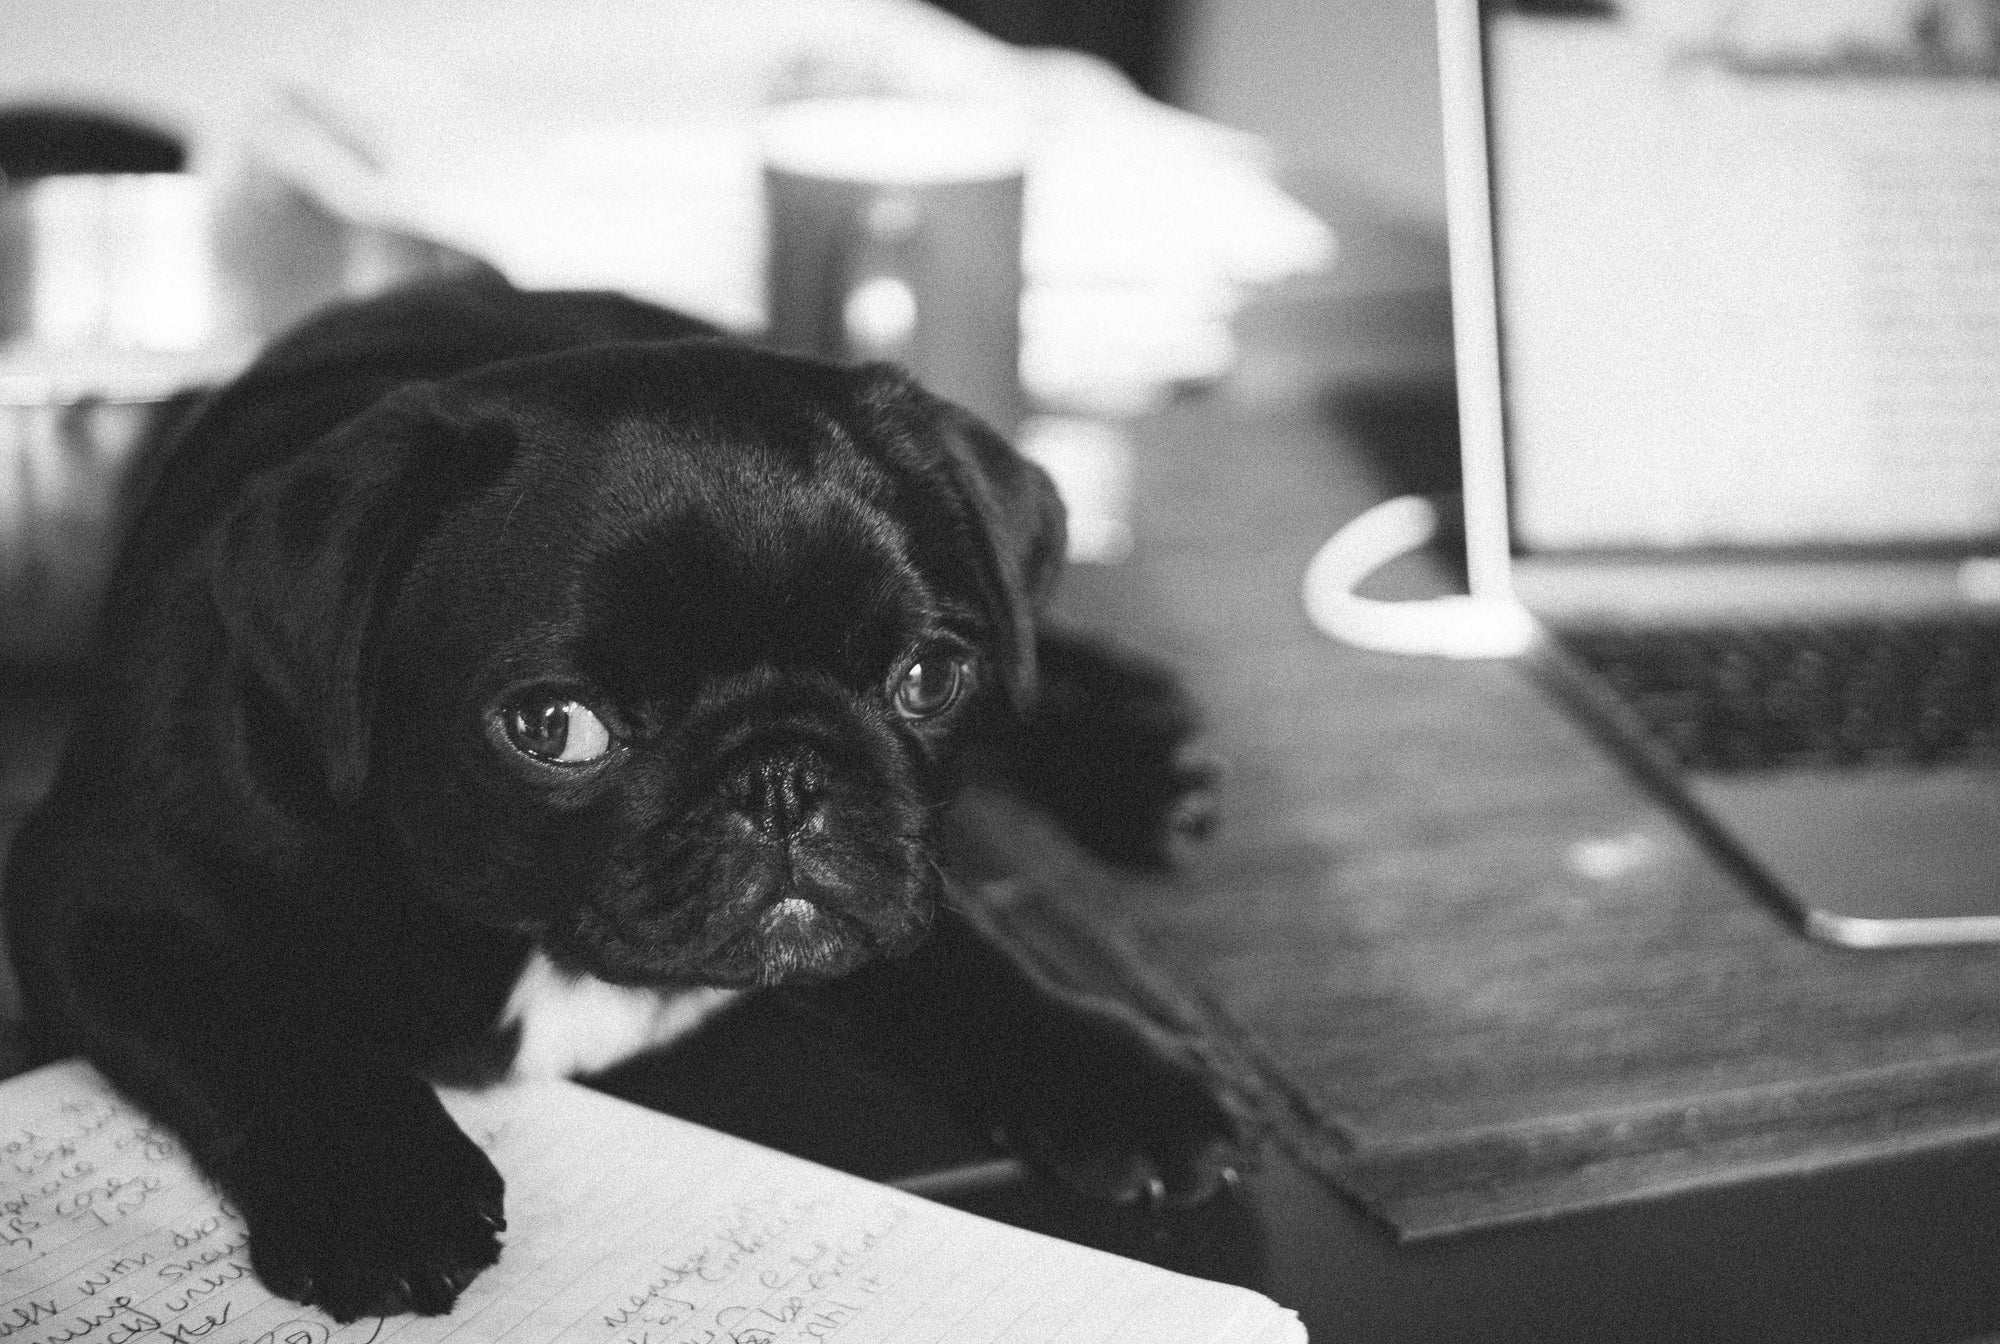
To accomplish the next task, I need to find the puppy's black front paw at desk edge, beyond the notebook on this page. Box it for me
[994,1008,1254,1208]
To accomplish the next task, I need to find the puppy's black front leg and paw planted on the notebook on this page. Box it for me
[8,816,504,1320]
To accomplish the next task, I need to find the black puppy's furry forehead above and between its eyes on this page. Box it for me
[492,420,950,698]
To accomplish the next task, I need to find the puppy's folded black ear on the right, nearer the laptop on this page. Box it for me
[860,364,1068,710]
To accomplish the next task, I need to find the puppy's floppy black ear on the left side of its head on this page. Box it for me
[210,386,514,802]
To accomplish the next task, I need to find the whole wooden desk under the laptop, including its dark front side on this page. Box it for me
[976,278,2000,1340]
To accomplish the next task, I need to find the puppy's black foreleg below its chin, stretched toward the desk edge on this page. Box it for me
[782,908,1250,1206]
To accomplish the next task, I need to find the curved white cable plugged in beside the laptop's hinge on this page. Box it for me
[1304,494,1536,658]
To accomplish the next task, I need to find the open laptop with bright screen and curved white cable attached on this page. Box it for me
[1308,0,2000,948]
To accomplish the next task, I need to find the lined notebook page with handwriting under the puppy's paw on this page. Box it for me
[0,1060,1306,1344]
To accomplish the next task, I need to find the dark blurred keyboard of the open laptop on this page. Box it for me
[1560,618,2000,772]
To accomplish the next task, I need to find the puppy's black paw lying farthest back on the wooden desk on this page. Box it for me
[1000,626,1218,870]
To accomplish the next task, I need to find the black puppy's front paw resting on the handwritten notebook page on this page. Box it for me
[224,1078,506,1322]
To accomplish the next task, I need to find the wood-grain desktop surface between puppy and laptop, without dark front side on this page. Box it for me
[1012,292,2000,1238]
